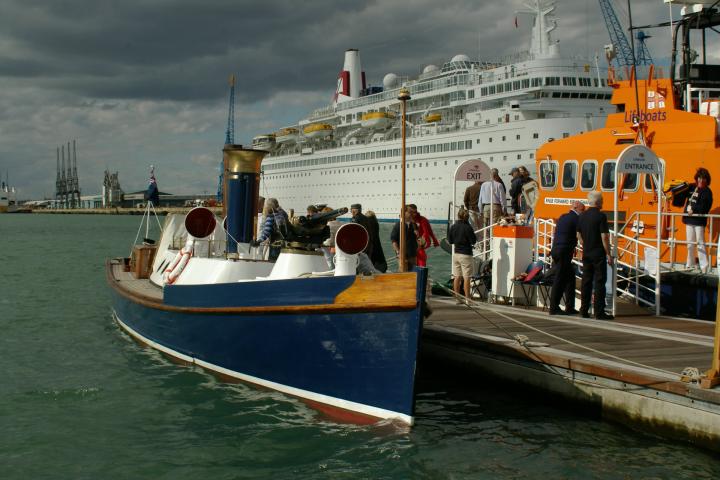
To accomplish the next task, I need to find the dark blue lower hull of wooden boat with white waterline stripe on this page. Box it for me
[106,264,425,424]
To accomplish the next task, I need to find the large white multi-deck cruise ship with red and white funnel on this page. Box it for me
[253,0,610,220]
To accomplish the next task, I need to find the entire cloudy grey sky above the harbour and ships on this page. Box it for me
[0,0,688,199]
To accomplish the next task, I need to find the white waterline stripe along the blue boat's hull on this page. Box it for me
[113,311,414,425]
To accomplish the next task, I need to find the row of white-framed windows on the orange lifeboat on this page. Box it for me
[539,160,654,192]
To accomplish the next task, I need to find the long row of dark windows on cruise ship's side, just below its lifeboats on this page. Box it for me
[264,133,544,172]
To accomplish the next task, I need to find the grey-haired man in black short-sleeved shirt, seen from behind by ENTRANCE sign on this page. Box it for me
[577,192,614,320]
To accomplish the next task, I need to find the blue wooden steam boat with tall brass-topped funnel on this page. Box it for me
[106,146,427,424]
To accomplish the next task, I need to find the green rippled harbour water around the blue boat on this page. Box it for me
[0,215,720,480]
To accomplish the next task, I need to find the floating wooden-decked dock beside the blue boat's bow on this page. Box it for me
[422,297,720,451]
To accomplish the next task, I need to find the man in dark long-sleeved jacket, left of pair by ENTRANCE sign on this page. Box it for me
[550,200,585,315]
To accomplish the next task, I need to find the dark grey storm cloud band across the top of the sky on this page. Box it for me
[0,0,659,101]
